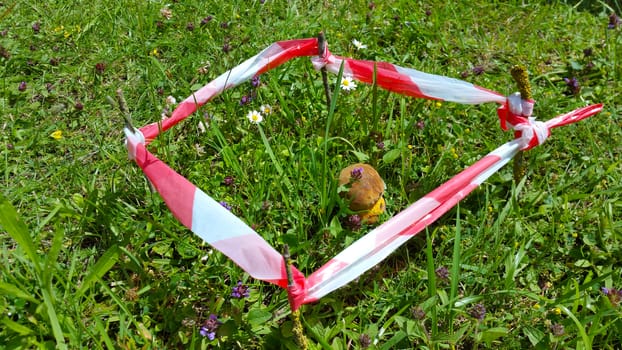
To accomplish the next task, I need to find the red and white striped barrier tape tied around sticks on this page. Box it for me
[125,38,602,309]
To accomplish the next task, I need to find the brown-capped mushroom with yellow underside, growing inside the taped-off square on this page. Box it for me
[339,163,386,215]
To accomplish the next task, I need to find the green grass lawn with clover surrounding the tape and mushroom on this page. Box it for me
[0,0,622,349]
